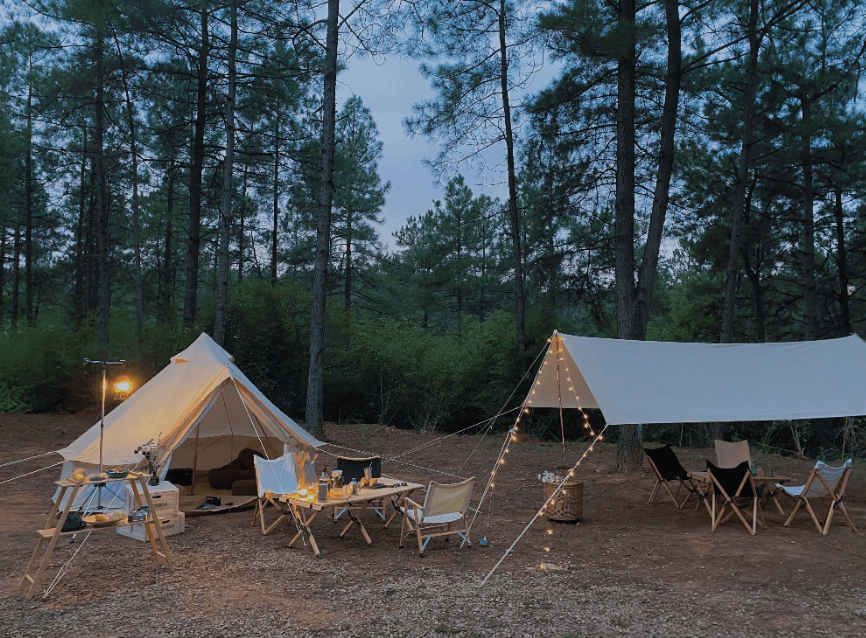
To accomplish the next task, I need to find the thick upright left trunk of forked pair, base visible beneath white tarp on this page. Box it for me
[614,0,643,473]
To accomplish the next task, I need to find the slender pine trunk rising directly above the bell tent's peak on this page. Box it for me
[214,0,238,346]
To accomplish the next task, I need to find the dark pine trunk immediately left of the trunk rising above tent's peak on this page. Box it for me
[183,0,210,329]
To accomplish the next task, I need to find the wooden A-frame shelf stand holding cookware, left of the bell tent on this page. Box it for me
[18,472,174,600]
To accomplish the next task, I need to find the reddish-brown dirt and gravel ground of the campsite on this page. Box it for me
[0,412,866,637]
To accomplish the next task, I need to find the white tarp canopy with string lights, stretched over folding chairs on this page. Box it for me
[527,334,866,425]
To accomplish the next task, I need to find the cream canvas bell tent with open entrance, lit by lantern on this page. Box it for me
[58,333,322,510]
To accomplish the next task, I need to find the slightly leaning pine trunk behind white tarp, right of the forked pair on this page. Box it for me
[719,0,761,343]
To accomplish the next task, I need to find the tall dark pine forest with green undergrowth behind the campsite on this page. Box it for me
[0,0,866,469]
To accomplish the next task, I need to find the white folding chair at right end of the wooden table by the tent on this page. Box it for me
[400,477,475,558]
